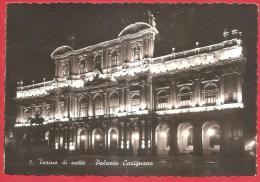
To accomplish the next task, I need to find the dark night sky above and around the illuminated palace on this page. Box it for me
[5,4,257,134]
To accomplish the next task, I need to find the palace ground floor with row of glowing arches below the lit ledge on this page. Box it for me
[11,109,244,156]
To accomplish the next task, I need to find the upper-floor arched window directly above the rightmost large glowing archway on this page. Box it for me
[202,83,218,106]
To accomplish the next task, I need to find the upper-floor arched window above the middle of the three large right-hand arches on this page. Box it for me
[178,86,192,108]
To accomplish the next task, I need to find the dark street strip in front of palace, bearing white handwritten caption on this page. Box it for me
[5,155,256,176]
